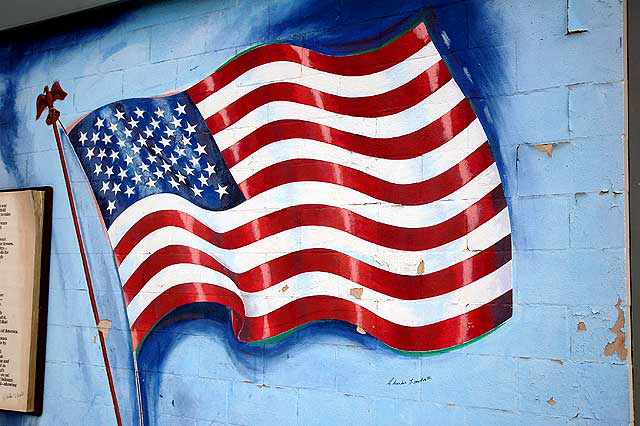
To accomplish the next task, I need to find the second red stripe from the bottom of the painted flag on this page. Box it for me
[123,236,511,305]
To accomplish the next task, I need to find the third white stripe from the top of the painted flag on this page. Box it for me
[231,119,487,184]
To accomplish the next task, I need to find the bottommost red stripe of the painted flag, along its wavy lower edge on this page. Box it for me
[131,290,512,351]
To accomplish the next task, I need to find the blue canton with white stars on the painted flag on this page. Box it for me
[69,93,245,227]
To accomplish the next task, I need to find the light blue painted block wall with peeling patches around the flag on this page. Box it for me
[0,0,630,426]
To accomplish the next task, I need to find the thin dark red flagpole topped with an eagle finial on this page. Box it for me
[36,82,122,426]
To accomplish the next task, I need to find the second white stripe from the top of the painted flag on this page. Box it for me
[214,80,464,150]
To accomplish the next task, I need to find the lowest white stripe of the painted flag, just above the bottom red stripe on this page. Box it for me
[127,262,511,327]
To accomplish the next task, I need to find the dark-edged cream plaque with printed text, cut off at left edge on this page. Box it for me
[0,187,53,414]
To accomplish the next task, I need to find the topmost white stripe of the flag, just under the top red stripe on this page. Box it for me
[197,42,441,118]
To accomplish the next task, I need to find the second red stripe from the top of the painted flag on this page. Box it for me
[206,61,451,134]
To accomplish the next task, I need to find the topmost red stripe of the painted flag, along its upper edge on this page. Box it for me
[187,23,430,103]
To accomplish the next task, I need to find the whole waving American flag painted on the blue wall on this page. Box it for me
[69,23,512,351]
